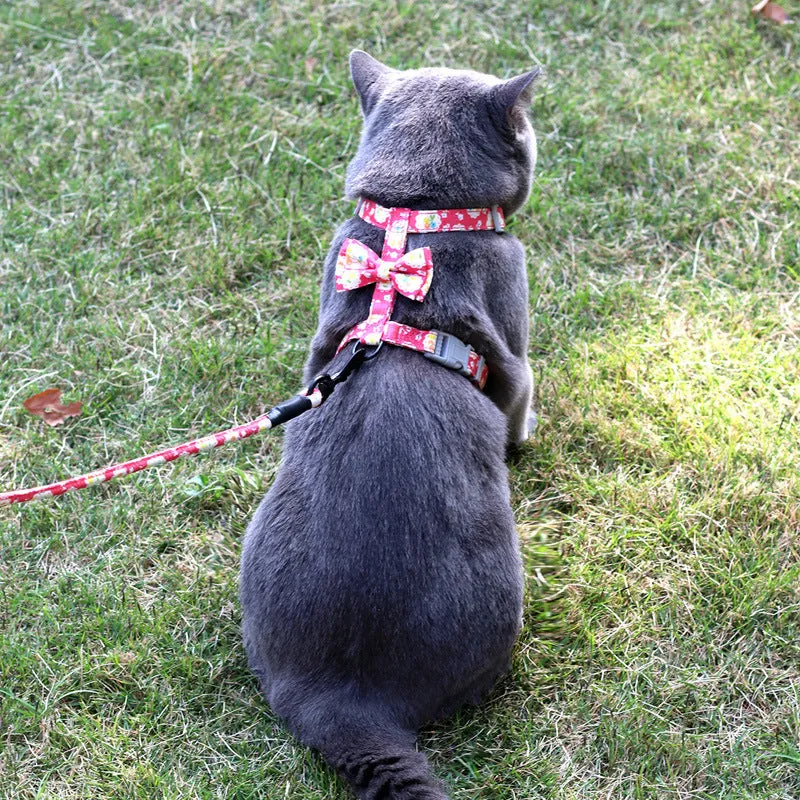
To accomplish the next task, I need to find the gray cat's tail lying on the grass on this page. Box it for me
[290,692,449,800]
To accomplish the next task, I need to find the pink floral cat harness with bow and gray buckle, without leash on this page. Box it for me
[336,198,505,389]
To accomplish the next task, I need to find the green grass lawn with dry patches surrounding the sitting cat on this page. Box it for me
[0,0,800,800]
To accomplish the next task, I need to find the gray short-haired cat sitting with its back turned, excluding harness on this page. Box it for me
[241,51,538,800]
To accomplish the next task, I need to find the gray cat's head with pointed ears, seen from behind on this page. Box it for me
[346,50,539,214]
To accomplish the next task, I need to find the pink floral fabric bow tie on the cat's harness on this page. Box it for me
[336,239,433,303]
